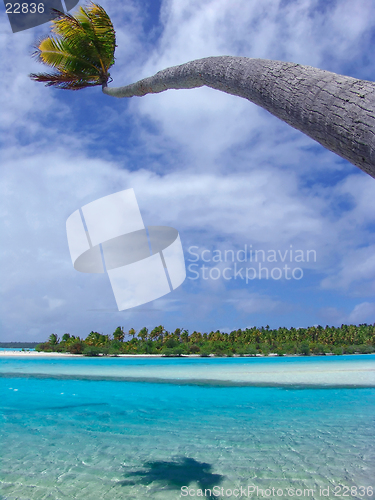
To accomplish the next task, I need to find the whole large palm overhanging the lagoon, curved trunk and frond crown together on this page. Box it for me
[31,3,375,177]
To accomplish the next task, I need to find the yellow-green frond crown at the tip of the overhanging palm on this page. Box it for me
[30,3,116,90]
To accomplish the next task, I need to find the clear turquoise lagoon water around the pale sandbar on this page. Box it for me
[0,355,375,500]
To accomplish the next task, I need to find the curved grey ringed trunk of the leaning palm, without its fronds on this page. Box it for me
[103,56,375,177]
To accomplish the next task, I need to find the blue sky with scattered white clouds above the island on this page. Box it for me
[0,0,375,341]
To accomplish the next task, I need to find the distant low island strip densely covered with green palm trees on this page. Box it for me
[32,323,375,356]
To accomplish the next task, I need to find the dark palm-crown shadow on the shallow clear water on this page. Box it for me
[118,457,224,490]
